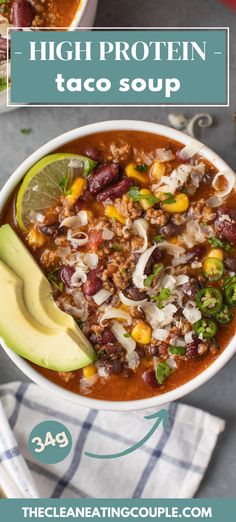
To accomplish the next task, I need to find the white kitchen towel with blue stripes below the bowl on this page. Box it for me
[0,382,225,498]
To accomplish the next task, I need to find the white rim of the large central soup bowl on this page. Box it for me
[0,120,236,411]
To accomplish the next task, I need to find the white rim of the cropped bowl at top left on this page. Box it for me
[0,0,98,113]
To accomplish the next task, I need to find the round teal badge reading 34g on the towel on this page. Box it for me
[28,420,72,464]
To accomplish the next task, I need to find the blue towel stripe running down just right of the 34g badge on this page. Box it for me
[51,410,97,498]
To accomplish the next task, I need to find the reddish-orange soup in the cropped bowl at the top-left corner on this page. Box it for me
[0,0,81,27]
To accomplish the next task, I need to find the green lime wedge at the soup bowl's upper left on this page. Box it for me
[16,153,97,231]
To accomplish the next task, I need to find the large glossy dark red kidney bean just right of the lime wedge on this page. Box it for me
[89,163,119,196]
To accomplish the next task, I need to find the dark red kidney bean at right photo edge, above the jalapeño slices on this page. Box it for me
[214,206,236,243]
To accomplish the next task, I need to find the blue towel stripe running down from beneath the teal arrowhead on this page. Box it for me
[133,403,178,498]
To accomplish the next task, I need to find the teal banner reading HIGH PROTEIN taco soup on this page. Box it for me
[9,29,228,106]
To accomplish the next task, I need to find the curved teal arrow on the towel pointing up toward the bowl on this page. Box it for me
[85,410,169,459]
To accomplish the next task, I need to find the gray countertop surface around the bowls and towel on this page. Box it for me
[0,0,236,497]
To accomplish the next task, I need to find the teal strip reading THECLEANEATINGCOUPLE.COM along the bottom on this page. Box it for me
[0,498,236,522]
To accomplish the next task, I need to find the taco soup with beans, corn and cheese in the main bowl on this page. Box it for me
[1,131,236,401]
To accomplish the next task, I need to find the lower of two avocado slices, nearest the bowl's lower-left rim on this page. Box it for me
[0,261,94,372]
